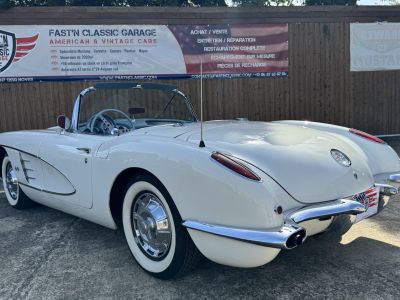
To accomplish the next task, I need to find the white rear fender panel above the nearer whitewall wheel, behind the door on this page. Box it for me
[93,137,299,228]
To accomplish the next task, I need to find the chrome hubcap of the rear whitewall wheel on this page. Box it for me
[132,192,172,260]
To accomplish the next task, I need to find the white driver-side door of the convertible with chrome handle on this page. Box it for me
[40,132,106,208]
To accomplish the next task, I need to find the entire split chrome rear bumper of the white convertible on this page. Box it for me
[182,184,398,249]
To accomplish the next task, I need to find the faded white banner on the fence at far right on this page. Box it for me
[350,23,400,71]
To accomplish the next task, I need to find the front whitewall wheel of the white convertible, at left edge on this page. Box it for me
[1,156,35,209]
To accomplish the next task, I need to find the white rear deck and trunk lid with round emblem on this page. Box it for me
[145,121,373,203]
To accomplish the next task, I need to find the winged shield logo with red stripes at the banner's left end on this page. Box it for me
[0,30,39,73]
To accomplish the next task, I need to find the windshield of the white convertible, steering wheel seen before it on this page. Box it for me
[78,88,196,134]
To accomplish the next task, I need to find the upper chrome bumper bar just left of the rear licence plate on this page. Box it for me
[285,199,365,223]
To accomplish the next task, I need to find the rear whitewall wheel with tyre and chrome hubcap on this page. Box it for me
[122,175,201,279]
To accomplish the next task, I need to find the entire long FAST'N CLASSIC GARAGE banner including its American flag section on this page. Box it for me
[0,24,289,83]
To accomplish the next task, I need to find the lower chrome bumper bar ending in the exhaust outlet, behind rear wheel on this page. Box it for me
[182,220,306,249]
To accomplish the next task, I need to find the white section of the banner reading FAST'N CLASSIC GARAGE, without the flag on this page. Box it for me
[0,25,186,79]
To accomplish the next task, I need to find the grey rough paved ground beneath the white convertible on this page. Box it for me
[0,143,400,300]
